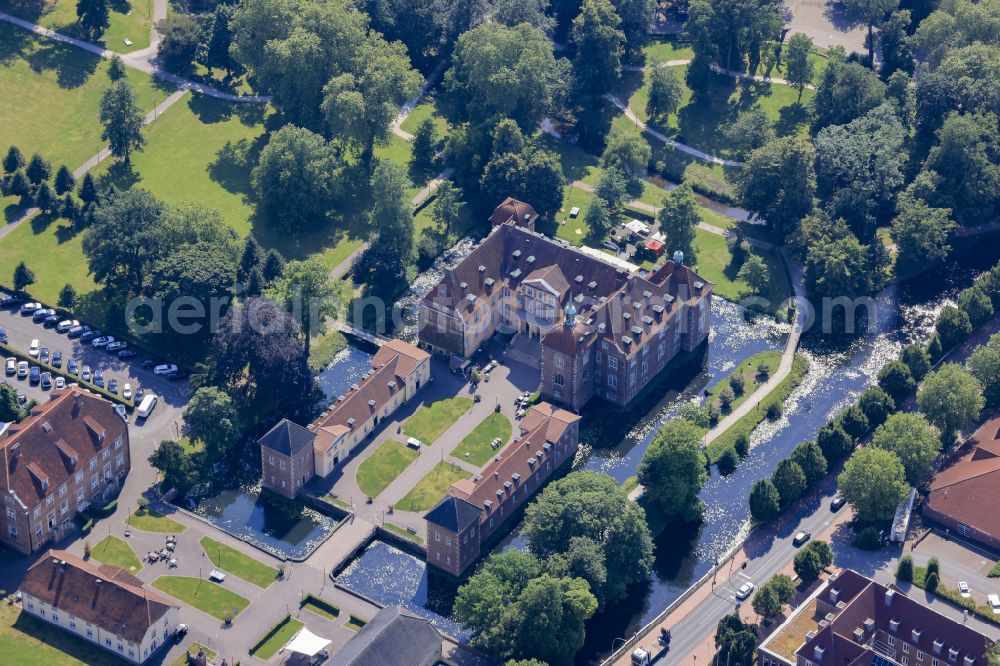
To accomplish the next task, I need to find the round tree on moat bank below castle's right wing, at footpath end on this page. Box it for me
[638,418,708,522]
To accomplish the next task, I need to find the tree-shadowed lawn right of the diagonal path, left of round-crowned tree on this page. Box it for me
[94,93,267,236]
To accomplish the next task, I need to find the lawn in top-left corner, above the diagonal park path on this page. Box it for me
[0,0,153,53]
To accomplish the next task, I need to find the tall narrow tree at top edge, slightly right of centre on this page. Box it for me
[571,0,625,96]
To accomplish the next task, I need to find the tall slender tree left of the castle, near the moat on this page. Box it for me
[355,162,413,304]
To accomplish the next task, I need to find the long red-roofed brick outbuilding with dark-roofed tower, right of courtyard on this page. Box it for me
[424,402,580,576]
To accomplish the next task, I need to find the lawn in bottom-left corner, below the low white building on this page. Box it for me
[0,603,126,666]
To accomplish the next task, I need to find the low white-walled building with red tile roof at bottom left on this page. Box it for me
[20,550,180,664]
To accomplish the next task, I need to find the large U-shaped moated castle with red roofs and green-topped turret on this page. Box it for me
[418,199,714,411]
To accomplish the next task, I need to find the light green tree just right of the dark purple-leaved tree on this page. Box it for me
[268,257,343,356]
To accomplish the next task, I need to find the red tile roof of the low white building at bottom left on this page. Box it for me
[20,550,178,643]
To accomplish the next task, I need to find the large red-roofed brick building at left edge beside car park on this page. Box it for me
[0,389,131,554]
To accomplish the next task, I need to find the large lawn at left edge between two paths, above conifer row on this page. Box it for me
[0,21,172,173]
